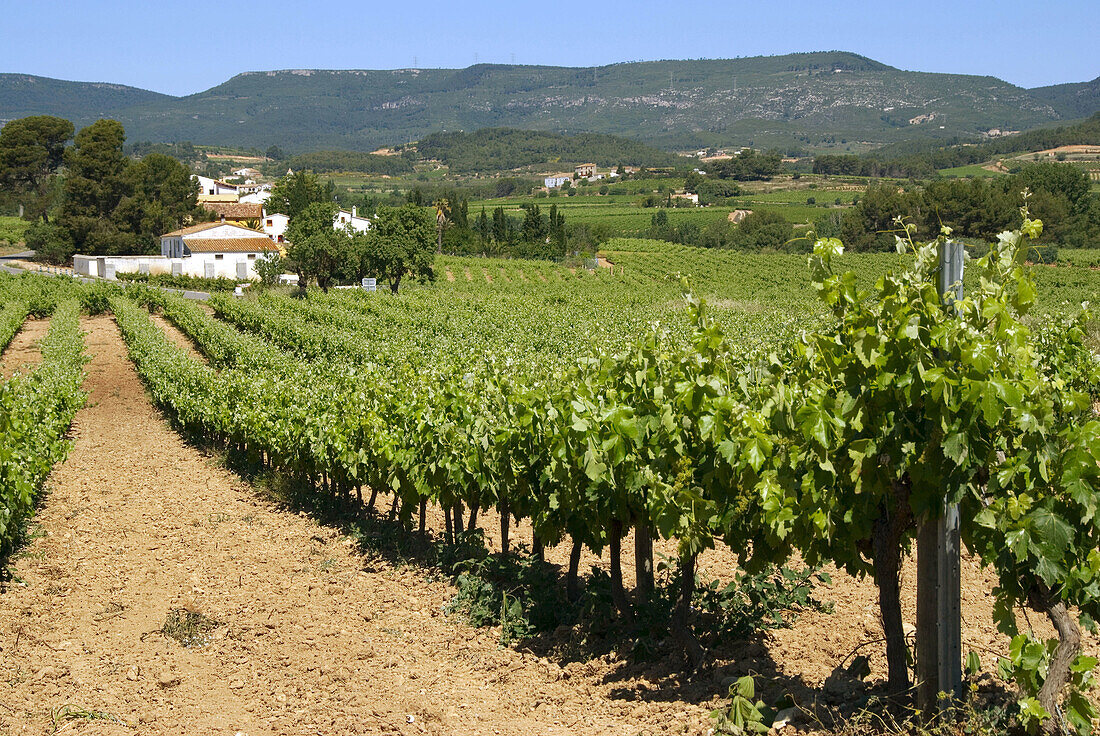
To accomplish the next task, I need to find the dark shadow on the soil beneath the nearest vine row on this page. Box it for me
[157,422,1012,736]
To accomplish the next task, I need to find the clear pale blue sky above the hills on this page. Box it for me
[0,0,1100,95]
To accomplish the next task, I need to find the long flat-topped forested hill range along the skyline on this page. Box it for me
[0,52,1100,152]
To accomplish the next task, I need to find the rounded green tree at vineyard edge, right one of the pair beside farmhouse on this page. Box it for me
[355,204,436,294]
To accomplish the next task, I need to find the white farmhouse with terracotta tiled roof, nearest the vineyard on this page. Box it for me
[161,222,278,281]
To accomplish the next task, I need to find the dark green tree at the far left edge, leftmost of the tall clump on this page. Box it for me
[0,116,73,222]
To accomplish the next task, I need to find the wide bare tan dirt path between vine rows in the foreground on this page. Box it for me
[0,317,705,736]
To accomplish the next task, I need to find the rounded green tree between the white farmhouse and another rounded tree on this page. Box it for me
[286,202,356,292]
